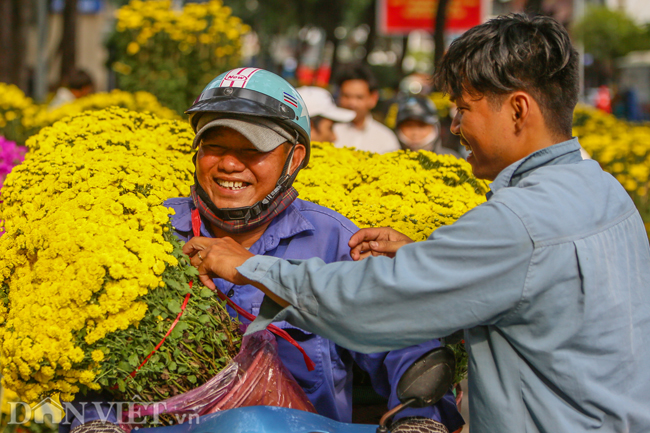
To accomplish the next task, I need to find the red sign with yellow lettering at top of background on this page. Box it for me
[377,0,481,35]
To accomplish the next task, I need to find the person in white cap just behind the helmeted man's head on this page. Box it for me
[297,86,356,143]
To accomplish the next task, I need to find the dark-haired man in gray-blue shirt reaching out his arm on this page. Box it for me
[185,15,650,433]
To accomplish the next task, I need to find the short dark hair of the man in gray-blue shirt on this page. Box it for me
[434,14,579,136]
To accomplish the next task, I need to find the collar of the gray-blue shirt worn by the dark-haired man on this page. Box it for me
[487,137,582,200]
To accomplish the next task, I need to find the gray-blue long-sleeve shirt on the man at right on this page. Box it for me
[238,139,650,433]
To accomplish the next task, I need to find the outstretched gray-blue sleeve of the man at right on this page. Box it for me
[238,202,533,353]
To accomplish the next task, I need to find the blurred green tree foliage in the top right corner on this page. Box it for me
[574,6,650,62]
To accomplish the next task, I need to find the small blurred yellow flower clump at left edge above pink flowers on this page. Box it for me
[0,83,42,144]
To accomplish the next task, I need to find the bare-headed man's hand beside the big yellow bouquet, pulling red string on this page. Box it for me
[183,236,253,290]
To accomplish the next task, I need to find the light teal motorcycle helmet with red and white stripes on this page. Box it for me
[185,68,311,166]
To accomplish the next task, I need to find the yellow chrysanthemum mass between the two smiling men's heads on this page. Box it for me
[295,143,488,241]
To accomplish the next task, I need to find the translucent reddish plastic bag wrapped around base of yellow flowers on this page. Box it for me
[120,331,316,433]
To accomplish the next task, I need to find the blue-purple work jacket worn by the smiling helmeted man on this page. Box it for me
[165,198,464,431]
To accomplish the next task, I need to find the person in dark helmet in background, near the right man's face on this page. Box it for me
[395,96,460,158]
